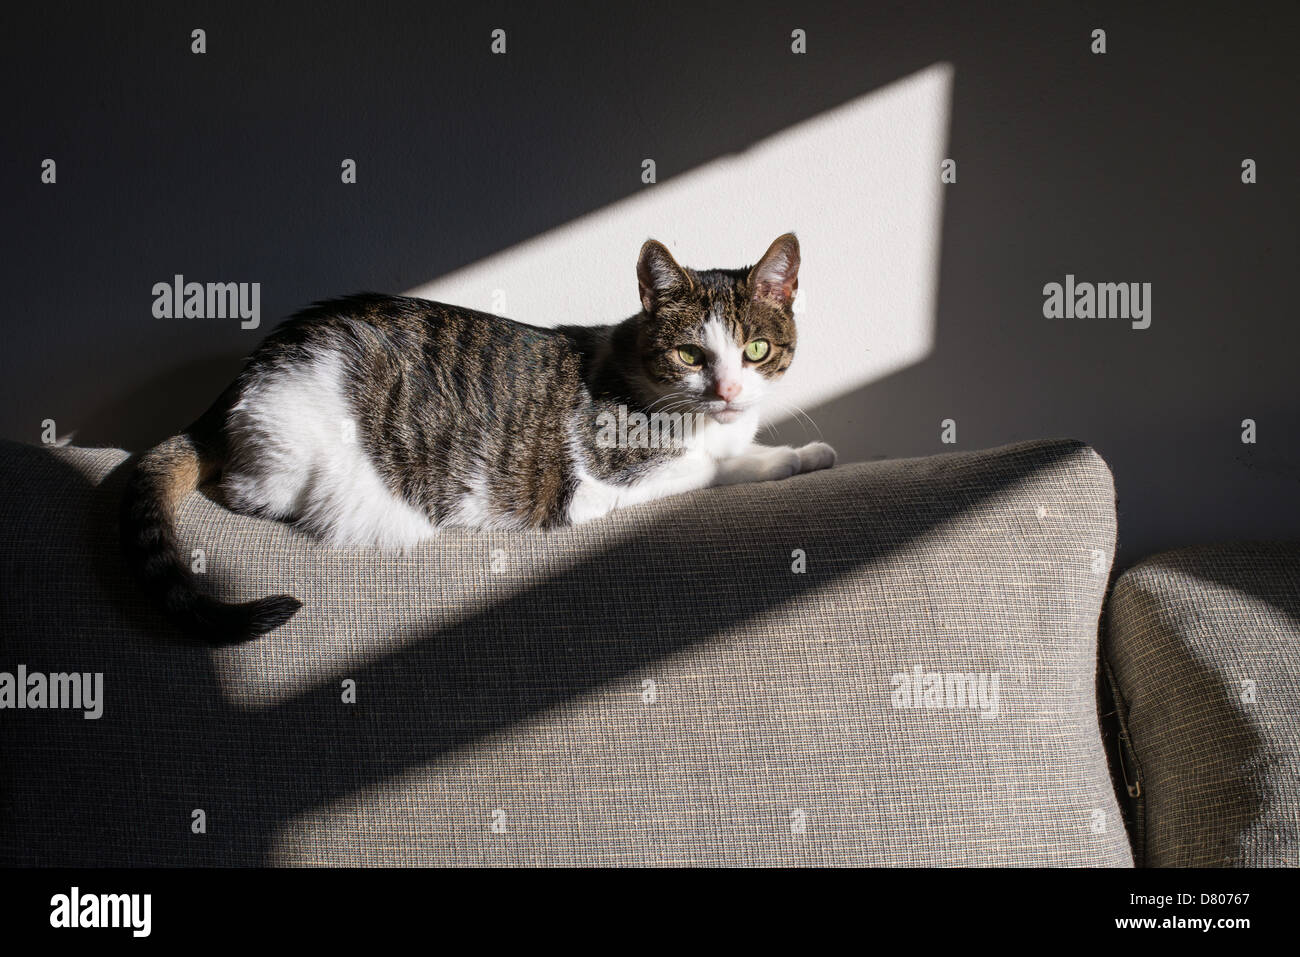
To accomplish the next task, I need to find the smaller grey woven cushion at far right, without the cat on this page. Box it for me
[1106,542,1300,867]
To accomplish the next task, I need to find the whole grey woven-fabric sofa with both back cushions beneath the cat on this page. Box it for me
[0,439,1300,867]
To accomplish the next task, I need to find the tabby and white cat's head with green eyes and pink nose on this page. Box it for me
[637,233,800,423]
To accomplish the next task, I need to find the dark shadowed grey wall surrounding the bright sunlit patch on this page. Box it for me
[0,3,1300,563]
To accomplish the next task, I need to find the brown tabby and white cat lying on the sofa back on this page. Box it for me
[121,233,836,645]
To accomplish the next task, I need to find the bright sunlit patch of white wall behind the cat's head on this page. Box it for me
[407,64,953,429]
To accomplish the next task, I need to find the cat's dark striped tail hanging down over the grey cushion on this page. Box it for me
[121,433,303,645]
